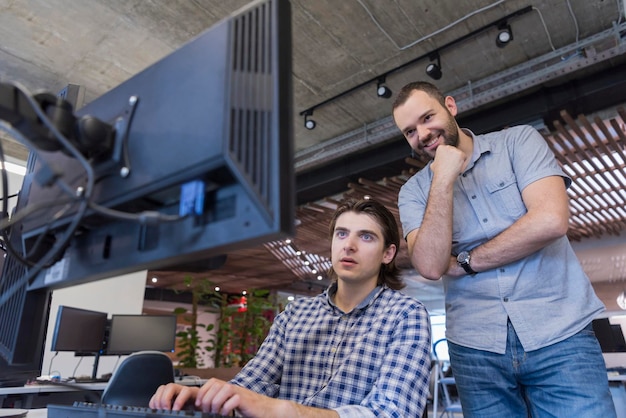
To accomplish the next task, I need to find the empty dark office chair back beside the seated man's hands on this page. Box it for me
[102,351,174,407]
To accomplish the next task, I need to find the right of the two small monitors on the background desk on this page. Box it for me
[106,315,176,355]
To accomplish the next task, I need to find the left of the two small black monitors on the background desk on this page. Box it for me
[50,305,107,354]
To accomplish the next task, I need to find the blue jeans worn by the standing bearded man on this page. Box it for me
[448,322,616,418]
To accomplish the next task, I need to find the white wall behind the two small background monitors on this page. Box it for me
[41,270,147,378]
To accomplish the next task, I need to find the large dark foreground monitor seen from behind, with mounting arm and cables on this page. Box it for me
[0,0,295,386]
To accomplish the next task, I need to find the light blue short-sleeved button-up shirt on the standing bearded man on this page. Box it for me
[398,126,604,354]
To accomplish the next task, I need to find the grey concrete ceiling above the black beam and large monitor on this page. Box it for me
[0,0,625,171]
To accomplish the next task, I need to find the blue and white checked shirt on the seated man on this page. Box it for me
[232,284,430,417]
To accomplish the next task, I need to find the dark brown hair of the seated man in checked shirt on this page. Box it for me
[329,199,406,290]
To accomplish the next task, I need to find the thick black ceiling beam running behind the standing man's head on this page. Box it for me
[296,55,626,204]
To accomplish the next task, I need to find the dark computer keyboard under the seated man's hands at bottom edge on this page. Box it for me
[48,402,229,418]
